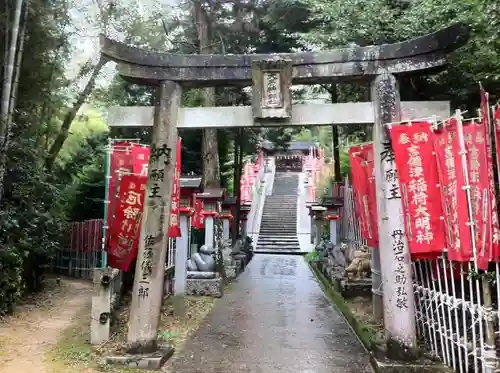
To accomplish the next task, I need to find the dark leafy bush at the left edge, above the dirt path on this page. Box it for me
[0,132,66,313]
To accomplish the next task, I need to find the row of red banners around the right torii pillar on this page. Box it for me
[349,92,500,270]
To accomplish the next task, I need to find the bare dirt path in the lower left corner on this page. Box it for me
[0,279,91,373]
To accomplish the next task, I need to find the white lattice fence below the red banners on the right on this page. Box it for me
[338,180,500,373]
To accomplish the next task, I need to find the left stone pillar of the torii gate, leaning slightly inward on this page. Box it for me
[127,81,182,353]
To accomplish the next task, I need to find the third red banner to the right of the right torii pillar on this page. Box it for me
[463,121,495,269]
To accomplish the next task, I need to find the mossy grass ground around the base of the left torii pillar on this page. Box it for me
[46,297,215,373]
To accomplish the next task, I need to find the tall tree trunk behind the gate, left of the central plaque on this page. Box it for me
[193,1,221,188]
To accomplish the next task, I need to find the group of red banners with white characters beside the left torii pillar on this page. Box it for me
[105,138,184,271]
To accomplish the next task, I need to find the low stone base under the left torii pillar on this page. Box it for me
[105,345,174,370]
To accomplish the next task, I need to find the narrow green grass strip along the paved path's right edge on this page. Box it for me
[309,262,381,351]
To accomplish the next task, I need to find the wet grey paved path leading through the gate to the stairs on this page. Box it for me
[165,254,373,373]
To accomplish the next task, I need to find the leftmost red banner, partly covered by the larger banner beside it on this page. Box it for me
[106,141,132,243]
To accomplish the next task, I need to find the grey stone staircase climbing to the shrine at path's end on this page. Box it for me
[254,172,301,254]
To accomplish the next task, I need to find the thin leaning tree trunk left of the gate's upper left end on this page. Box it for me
[46,57,108,169]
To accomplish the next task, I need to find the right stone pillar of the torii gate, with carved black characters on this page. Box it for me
[371,73,417,360]
